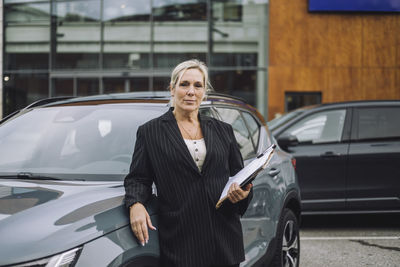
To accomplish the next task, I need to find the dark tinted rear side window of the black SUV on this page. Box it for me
[358,107,400,140]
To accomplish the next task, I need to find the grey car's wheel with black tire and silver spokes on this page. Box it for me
[272,209,300,267]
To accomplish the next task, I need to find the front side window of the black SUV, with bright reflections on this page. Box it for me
[284,109,346,144]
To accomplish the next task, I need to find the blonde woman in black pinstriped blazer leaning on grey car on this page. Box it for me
[125,60,252,267]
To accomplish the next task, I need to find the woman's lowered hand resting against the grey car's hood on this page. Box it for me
[129,202,157,246]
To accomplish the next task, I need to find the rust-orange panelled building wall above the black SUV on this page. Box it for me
[268,0,400,119]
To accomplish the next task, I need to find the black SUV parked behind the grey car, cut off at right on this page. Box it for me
[272,101,400,214]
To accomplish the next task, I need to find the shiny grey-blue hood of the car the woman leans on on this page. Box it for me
[0,179,155,265]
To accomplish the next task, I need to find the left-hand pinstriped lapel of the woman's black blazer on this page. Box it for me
[161,108,202,174]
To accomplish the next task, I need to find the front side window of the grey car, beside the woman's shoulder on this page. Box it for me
[217,108,255,159]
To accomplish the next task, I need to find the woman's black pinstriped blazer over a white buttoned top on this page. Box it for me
[124,108,252,267]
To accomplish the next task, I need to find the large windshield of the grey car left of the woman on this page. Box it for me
[0,104,167,180]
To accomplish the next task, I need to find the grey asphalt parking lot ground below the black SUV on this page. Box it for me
[300,214,400,267]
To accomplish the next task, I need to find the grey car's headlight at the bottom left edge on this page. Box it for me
[12,248,81,267]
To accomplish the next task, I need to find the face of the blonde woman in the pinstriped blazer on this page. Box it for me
[171,69,206,112]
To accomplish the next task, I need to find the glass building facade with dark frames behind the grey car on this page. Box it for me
[3,0,268,116]
